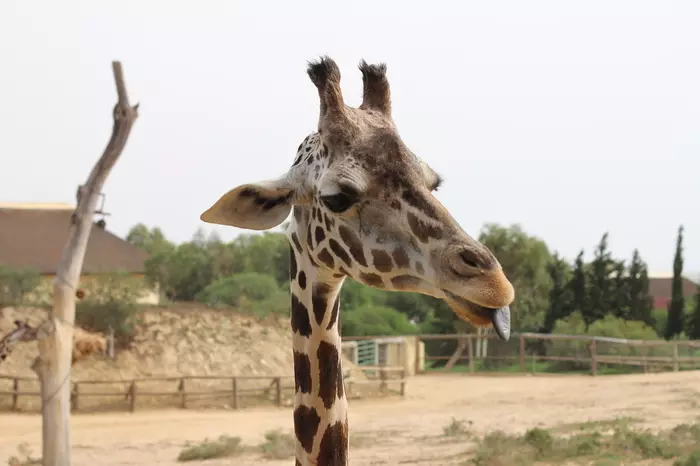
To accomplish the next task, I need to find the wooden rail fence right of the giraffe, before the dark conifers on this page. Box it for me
[343,333,700,375]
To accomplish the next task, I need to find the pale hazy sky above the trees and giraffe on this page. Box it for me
[0,0,700,274]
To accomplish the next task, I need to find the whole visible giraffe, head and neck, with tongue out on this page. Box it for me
[200,56,515,466]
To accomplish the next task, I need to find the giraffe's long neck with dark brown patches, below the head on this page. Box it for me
[290,237,348,466]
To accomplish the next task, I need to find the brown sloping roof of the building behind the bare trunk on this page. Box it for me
[0,204,148,274]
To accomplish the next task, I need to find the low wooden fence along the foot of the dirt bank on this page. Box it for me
[0,366,407,412]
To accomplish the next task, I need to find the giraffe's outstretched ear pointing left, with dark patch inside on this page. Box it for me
[199,180,294,230]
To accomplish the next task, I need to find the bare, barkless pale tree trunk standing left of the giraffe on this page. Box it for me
[32,61,138,466]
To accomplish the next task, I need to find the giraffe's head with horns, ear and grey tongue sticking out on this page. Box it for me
[201,57,514,340]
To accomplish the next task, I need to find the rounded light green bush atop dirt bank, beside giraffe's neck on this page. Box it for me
[196,272,280,307]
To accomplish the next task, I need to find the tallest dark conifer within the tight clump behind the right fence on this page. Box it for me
[582,233,614,328]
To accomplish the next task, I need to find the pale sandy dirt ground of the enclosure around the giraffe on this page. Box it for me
[0,372,700,466]
